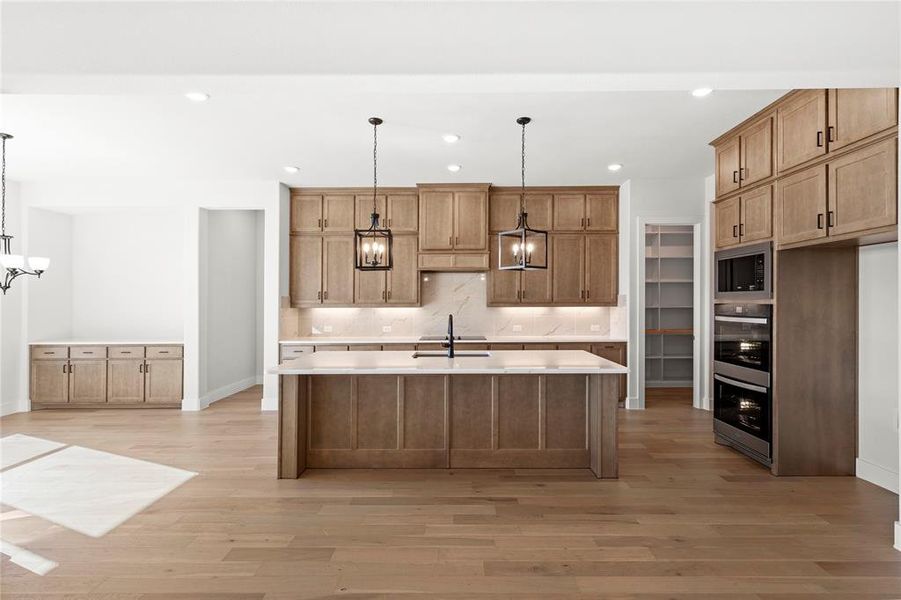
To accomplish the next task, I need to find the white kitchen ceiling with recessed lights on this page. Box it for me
[0,1,899,185]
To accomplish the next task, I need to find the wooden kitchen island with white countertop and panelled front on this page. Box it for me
[272,350,628,479]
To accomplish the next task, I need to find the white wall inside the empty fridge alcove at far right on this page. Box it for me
[857,243,898,494]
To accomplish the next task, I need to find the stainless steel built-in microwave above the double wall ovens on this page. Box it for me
[714,242,773,302]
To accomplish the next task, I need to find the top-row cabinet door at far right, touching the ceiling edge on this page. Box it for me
[827,88,898,150]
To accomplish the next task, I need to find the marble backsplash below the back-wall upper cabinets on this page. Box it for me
[281,273,628,339]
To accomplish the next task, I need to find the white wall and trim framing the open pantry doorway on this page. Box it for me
[620,179,710,408]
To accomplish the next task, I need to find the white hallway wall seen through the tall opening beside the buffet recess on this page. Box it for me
[201,210,263,405]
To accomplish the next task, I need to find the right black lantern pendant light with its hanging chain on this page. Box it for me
[497,117,547,271]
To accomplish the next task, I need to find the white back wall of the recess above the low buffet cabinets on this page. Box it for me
[72,208,184,341]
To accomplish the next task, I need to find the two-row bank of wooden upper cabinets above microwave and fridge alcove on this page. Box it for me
[712,88,898,248]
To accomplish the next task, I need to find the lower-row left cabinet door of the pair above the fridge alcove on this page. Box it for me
[776,165,826,244]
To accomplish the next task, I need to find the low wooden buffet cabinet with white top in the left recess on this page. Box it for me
[30,345,183,409]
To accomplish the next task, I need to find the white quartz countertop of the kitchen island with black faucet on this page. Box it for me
[269,350,629,375]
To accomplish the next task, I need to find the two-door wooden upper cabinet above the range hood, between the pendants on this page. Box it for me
[419,184,488,252]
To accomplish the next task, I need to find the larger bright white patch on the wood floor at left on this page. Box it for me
[0,446,197,537]
